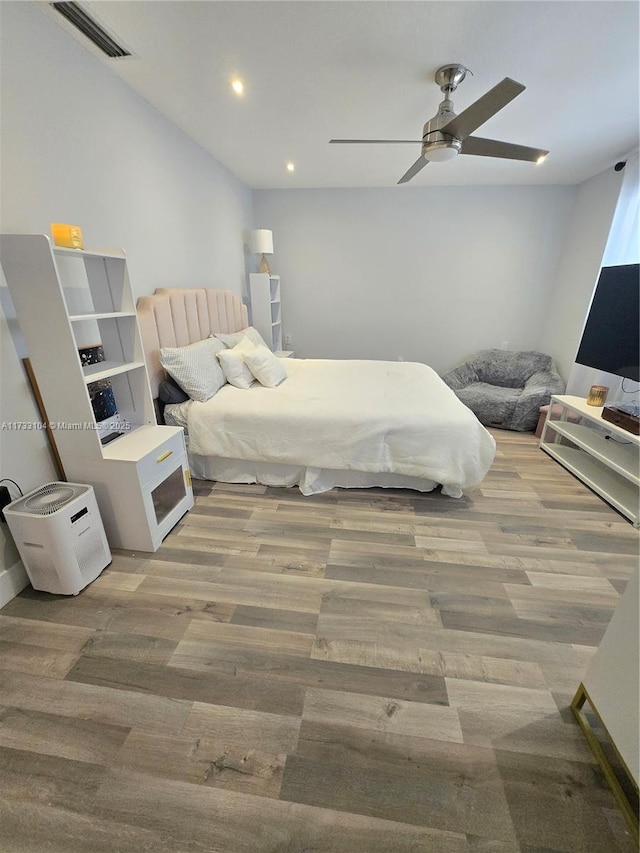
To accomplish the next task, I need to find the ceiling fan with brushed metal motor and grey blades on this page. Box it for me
[329,63,549,184]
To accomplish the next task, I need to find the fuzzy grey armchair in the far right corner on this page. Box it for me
[442,349,564,432]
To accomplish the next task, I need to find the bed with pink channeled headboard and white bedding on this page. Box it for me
[137,288,495,497]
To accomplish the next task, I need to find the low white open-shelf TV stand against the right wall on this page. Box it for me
[540,395,640,527]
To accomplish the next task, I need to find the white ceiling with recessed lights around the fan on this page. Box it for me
[45,0,639,192]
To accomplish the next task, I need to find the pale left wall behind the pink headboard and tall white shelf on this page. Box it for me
[0,2,253,603]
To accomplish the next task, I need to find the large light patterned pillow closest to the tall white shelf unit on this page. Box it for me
[160,338,226,403]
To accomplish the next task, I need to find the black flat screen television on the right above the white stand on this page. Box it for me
[576,264,640,382]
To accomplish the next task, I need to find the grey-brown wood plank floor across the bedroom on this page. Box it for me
[0,431,638,853]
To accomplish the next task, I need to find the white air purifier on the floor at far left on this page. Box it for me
[4,483,111,595]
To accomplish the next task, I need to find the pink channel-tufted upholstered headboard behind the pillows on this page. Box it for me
[136,287,249,397]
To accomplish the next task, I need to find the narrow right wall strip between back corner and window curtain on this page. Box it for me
[541,167,623,396]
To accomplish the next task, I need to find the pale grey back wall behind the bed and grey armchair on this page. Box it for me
[254,185,576,372]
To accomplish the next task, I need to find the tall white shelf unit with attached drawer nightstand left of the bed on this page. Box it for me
[0,234,193,551]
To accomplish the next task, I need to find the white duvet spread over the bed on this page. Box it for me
[182,359,495,496]
